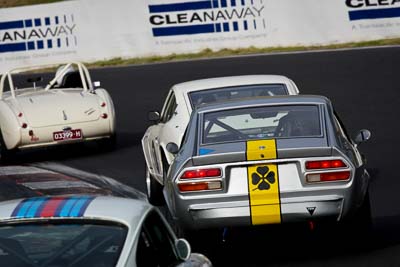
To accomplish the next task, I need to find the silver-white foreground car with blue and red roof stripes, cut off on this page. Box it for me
[0,166,211,267]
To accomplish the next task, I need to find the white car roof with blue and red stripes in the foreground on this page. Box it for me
[0,195,153,226]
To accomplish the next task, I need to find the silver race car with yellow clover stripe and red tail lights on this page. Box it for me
[164,96,371,229]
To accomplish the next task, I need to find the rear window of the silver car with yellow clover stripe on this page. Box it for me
[202,105,322,144]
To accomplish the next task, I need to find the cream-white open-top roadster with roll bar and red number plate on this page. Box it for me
[0,62,115,157]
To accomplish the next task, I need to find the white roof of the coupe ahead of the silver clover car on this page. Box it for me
[172,75,291,94]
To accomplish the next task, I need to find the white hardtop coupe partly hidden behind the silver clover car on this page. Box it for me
[142,75,299,205]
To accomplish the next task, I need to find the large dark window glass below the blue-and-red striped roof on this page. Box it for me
[0,221,128,267]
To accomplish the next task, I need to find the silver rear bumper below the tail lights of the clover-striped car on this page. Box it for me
[165,172,368,229]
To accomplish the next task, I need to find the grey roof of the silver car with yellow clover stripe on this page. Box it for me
[196,95,330,113]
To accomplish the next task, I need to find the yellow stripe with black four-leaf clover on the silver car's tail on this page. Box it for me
[246,140,281,225]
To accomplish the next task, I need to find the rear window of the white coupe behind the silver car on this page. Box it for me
[189,84,288,109]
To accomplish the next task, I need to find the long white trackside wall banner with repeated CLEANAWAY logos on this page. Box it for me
[0,0,400,72]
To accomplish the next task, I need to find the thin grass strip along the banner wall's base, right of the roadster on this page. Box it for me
[86,38,400,68]
